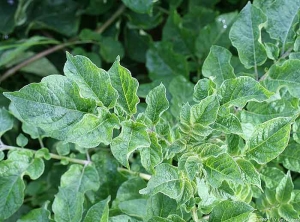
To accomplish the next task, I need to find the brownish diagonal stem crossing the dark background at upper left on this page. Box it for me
[0,5,126,84]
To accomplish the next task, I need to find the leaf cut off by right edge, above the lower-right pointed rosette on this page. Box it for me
[279,141,300,173]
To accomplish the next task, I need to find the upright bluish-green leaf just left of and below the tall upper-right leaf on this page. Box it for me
[202,45,235,86]
